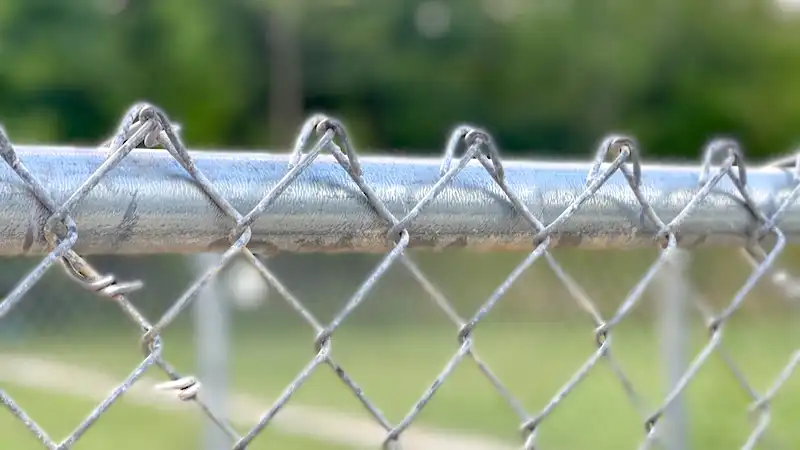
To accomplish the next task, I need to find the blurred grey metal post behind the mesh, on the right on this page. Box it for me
[658,249,692,450]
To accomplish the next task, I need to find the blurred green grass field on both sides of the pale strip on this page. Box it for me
[0,317,800,450]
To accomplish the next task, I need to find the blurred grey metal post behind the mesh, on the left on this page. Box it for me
[192,253,231,450]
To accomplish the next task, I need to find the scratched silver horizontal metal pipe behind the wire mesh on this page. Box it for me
[0,146,800,256]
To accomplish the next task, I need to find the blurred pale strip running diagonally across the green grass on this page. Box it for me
[0,354,517,450]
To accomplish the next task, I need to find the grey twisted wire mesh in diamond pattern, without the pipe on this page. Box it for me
[0,104,800,449]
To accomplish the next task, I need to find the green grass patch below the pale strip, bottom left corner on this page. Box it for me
[0,386,346,450]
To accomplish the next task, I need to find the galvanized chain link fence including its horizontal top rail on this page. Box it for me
[0,104,800,449]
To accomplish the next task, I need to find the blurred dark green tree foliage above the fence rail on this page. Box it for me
[0,0,800,158]
